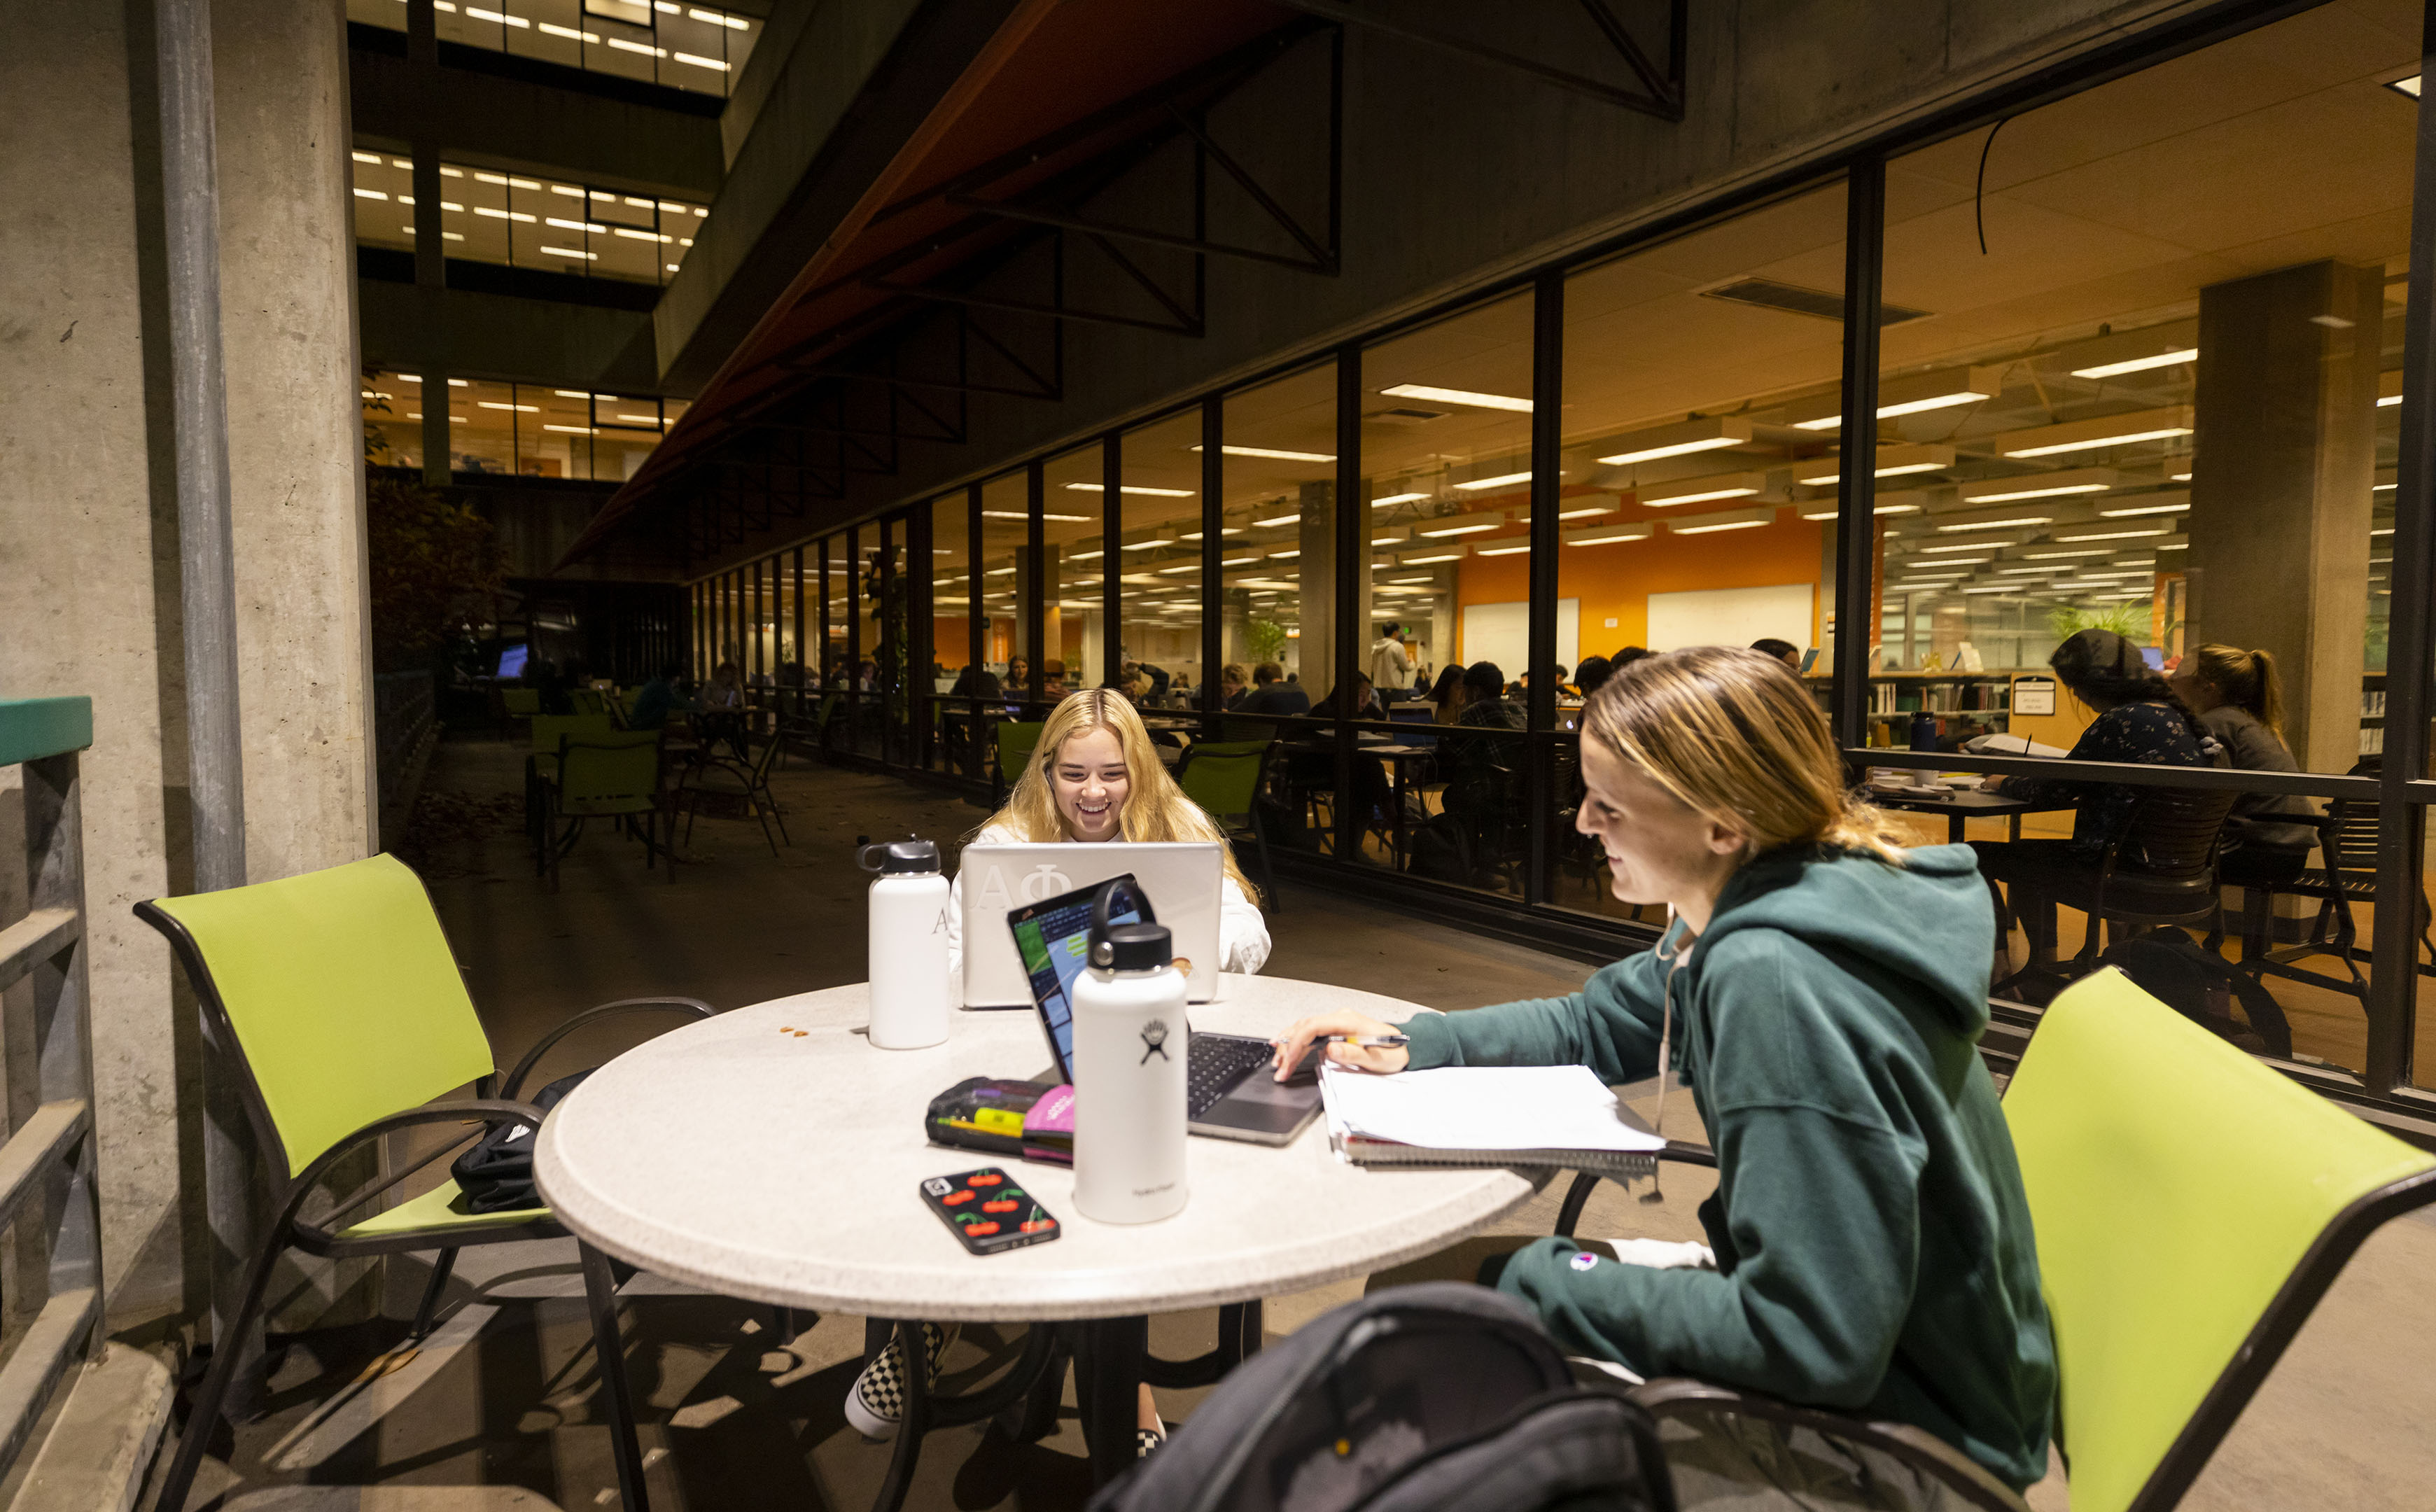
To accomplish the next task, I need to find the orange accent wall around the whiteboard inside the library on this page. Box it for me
[1455,504,1832,660]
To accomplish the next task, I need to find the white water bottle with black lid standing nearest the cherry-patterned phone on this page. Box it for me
[1074,894,1191,1222]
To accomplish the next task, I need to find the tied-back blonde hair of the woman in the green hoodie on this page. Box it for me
[1581,645,1903,867]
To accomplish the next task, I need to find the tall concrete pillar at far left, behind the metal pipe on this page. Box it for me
[0,0,372,1322]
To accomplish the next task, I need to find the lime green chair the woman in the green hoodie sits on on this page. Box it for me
[1557,967,2436,1512]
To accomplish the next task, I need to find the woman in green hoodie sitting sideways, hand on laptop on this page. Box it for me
[1279,648,2056,1488]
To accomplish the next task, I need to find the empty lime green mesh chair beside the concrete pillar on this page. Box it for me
[136,855,711,1512]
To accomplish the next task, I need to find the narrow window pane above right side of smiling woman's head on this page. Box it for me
[1118,409,1203,687]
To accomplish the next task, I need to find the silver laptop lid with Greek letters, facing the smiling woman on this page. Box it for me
[958,840,1220,1008]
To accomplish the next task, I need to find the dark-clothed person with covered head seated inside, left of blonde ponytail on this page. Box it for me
[1970,631,2224,952]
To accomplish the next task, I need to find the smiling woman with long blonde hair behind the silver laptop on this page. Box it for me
[948,687,1269,981]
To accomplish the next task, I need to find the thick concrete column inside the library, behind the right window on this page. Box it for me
[2185,260,2385,772]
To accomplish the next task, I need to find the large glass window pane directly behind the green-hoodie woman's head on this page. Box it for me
[1559,183,1844,918]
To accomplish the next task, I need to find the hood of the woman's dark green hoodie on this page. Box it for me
[1686,845,1995,1040]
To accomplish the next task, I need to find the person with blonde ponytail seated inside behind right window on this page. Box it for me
[2166,645,2316,886]
